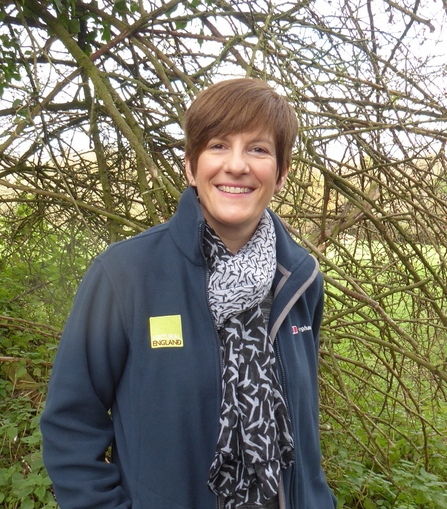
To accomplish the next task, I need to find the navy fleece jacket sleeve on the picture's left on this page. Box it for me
[41,260,131,509]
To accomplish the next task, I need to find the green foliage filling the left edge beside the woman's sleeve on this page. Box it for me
[0,204,102,509]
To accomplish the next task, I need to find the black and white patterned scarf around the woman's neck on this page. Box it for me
[204,211,294,509]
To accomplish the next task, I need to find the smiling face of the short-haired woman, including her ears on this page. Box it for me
[186,131,285,253]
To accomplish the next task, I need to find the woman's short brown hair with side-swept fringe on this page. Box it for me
[184,78,298,180]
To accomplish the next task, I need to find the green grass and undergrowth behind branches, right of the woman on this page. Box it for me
[321,235,447,509]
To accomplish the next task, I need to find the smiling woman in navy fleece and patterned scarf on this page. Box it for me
[41,79,336,509]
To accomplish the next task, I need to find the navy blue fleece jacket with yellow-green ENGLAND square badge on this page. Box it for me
[41,188,336,509]
